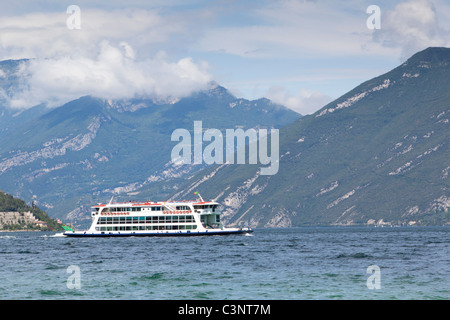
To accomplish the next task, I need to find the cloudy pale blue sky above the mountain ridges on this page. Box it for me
[0,0,450,115]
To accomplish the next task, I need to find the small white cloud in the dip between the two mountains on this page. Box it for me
[266,86,333,115]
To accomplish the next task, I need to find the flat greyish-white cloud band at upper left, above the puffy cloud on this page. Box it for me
[0,8,200,60]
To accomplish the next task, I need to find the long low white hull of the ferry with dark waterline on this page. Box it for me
[64,228,253,238]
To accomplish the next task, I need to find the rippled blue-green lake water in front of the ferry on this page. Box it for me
[0,227,450,300]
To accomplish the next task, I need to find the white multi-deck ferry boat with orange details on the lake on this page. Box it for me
[63,193,253,237]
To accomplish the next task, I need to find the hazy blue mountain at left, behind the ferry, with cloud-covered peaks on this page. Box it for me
[0,60,300,224]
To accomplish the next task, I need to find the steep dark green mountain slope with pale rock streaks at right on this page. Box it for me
[173,48,450,227]
